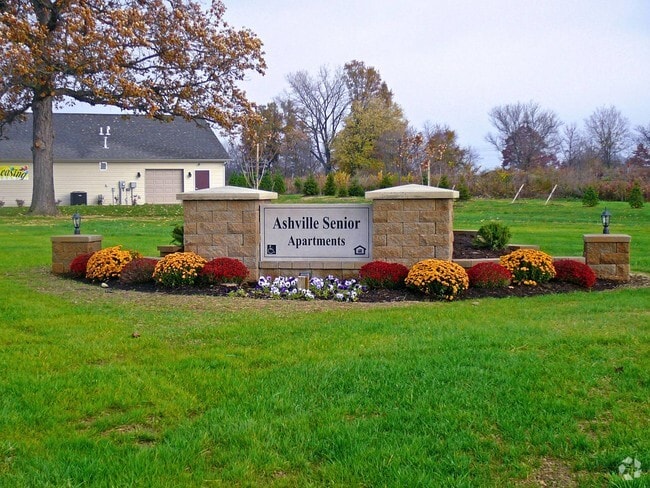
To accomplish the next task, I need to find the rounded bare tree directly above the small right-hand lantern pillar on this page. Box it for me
[585,106,631,167]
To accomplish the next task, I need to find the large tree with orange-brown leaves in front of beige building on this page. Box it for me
[0,0,266,215]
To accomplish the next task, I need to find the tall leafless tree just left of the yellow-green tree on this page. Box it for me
[280,66,350,173]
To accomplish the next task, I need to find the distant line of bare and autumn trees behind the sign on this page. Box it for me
[229,60,650,199]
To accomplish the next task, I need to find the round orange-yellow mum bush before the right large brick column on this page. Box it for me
[405,259,469,300]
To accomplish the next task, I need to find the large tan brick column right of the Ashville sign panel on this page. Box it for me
[366,185,458,267]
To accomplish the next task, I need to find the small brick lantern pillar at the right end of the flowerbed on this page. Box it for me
[583,234,632,281]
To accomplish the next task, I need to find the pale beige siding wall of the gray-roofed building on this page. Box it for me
[0,161,225,207]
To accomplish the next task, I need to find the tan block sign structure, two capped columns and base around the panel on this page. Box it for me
[178,185,458,279]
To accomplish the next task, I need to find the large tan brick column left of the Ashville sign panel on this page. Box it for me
[177,186,278,279]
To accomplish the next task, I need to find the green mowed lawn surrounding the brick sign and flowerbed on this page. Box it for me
[0,197,650,487]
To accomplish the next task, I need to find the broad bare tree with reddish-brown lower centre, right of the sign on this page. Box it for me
[486,102,562,170]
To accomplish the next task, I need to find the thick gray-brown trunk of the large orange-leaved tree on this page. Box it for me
[29,97,58,215]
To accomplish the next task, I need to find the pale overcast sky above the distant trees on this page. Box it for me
[224,0,650,167]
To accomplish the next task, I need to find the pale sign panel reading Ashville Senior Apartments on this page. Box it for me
[260,204,372,261]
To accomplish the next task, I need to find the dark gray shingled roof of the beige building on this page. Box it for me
[0,113,229,162]
